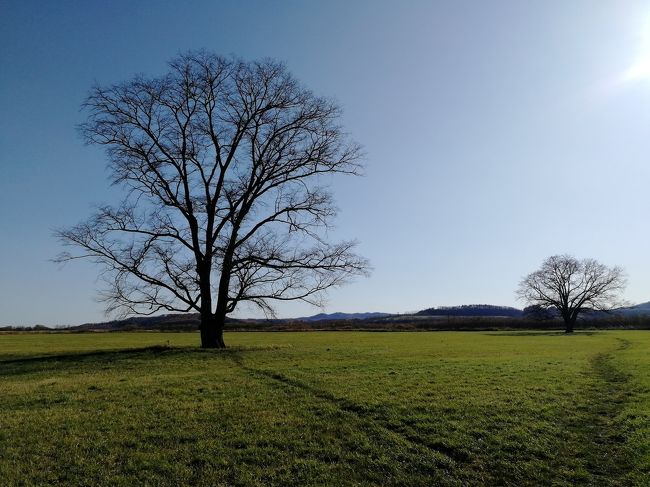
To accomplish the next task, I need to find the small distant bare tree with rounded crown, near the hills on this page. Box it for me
[517,255,626,333]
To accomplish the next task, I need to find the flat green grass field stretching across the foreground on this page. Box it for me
[0,331,650,486]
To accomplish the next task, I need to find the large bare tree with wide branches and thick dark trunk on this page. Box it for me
[57,51,368,347]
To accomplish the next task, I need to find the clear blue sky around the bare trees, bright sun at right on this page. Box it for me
[0,0,650,325]
